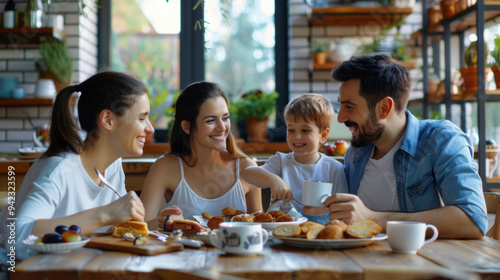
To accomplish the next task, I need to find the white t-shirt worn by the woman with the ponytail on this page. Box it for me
[0,153,127,260]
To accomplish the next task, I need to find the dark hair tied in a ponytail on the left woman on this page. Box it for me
[42,71,146,158]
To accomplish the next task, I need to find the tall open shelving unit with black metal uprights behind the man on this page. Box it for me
[416,0,500,191]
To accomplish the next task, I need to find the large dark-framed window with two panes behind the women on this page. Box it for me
[99,0,288,141]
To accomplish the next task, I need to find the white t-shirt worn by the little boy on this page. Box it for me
[262,152,347,212]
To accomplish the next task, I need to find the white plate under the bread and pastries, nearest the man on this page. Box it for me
[272,233,387,249]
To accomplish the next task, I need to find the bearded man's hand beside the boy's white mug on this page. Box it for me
[323,193,375,224]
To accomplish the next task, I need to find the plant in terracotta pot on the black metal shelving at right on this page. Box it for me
[460,41,491,98]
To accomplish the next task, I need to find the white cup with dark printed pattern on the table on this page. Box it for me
[210,222,269,255]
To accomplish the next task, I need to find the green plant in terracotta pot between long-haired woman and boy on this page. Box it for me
[229,89,278,142]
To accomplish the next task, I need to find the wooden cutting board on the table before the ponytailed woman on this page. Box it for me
[85,236,184,256]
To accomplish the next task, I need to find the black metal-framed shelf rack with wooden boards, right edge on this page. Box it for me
[413,0,500,191]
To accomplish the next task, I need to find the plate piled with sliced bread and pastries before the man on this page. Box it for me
[272,219,387,249]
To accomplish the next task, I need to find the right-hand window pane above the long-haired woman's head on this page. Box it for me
[205,0,276,96]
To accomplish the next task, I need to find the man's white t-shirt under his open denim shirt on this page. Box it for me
[358,135,404,211]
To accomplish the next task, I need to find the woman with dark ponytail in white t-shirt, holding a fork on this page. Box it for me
[0,72,154,264]
